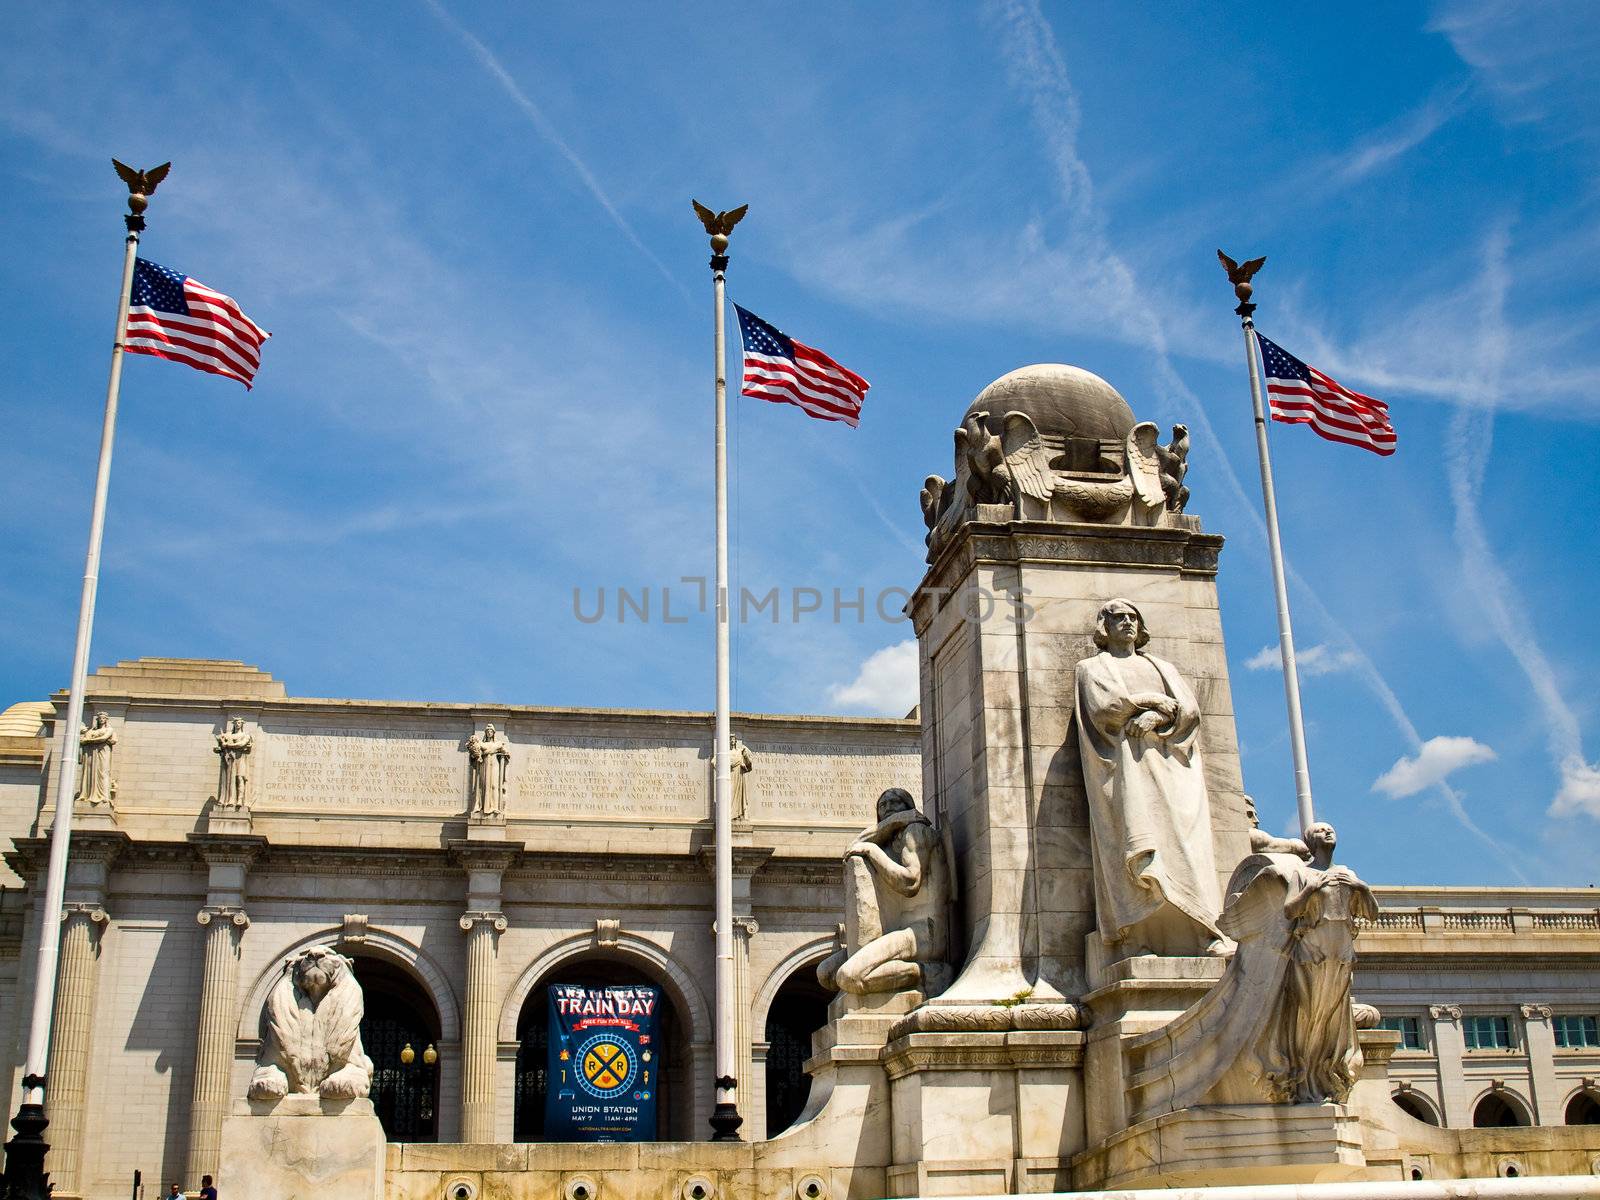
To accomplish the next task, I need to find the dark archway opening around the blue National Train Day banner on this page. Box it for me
[512,958,694,1142]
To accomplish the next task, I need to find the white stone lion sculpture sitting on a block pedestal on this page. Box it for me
[248,946,373,1099]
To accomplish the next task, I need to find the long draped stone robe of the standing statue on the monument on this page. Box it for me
[1077,651,1222,950]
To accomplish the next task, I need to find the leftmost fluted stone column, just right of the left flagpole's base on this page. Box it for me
[45,902,107,1195]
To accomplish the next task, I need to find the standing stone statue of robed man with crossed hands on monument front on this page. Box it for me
[1075,600,1229,957]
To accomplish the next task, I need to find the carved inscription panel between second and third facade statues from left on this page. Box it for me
[261,726,467,810]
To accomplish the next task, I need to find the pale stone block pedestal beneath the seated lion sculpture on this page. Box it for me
[216,1096,387,1200]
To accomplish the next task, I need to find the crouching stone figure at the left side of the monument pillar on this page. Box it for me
[816,787,954,995]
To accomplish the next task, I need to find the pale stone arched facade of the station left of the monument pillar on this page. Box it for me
[0,659,920,1197]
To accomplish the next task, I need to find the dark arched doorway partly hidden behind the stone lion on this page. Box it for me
[352,954,438,1142]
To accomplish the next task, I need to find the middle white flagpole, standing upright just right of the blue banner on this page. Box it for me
[696,202,744,1141]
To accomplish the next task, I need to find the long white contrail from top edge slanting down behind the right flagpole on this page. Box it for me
[997,0,1526,882]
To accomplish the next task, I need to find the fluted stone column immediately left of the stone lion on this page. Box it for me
[187,904,250,1179]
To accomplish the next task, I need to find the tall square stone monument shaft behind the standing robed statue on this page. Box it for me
[910,521,1250,1005]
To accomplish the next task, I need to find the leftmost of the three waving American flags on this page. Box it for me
[123,258,272,389]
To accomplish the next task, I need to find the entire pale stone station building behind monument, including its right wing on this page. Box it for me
[0,659,1600,1200]
